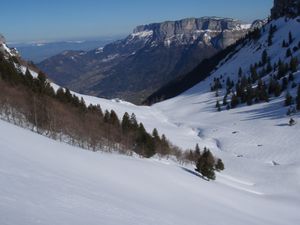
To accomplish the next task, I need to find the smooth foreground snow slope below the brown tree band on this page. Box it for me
[0,121,299,225]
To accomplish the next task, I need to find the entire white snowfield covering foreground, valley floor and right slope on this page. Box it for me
[0,19,300,225]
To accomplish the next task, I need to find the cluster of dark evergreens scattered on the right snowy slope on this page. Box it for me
[211,28,300,115]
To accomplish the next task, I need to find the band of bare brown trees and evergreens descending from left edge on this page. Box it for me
[0,52,224,178]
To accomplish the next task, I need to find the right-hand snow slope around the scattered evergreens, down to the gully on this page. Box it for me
[153,19,300,195]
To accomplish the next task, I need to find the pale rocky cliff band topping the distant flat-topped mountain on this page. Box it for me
[133,17,250,48]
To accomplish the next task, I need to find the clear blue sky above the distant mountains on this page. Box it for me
[0,0,273,42]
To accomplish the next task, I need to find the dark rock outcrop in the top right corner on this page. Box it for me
[271,0,300,19]
